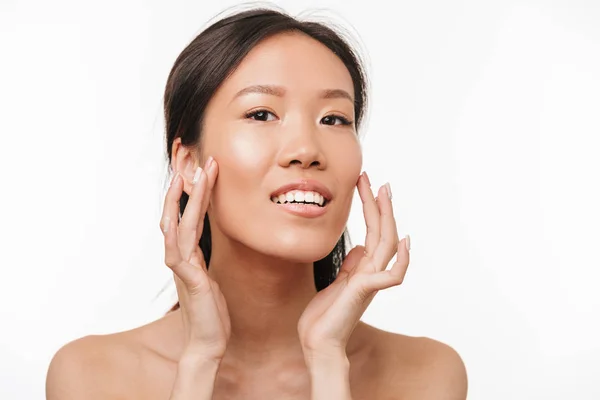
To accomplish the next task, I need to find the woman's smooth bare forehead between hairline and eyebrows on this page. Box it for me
[219,32,354,96]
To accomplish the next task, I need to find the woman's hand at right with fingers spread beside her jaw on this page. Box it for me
[298,174,410,362]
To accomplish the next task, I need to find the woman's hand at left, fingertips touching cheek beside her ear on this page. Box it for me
[160,157,231,361]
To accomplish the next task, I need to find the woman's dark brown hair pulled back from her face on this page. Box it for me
[164,8,367,311]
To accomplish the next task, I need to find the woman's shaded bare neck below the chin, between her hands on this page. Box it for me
[208,236,317,362]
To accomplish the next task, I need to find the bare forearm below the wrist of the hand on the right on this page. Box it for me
[307,354,352,400]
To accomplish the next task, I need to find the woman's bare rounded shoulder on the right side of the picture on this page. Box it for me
[358,327,468,400]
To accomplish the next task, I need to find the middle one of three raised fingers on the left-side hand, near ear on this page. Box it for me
[179,167,208,260]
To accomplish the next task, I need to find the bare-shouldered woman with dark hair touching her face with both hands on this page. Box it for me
[47,9,467,400]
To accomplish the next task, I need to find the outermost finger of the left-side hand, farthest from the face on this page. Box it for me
[160,173,196,284]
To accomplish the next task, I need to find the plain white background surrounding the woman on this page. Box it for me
[0,0,600,400]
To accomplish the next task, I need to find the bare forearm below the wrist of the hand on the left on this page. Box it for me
[169,353,220,400]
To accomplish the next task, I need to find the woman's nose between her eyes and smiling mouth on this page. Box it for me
[278,119,327,170]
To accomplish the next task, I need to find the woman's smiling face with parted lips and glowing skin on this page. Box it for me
[201,33,362,262]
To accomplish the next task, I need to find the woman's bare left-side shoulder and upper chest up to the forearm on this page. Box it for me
[46,313,181,400]
